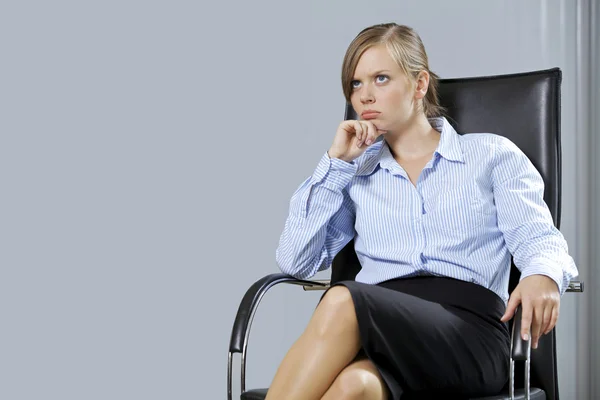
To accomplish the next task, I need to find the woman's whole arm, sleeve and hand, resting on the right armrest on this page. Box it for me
[493,139,577,349]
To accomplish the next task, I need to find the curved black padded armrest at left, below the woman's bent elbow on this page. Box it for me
[229,273,329,353]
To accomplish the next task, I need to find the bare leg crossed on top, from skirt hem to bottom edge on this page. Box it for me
[266,286,360,400]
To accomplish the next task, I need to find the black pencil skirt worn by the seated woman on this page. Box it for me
[324,276,510,400]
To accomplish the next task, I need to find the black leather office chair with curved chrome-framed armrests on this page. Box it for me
[227,68,583,400]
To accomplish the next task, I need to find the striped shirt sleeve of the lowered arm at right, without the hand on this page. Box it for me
[493,138,578,295]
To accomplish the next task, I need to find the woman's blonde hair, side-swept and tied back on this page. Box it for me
[342,23,444,118]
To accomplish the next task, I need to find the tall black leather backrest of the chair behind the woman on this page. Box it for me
[331,68,562,400]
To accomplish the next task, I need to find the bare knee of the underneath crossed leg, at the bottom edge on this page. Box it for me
[321,357,389,400]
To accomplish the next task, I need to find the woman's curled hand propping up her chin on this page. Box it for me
[327,120,386,162]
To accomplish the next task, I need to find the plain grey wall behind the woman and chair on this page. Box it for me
[0,0,600,400]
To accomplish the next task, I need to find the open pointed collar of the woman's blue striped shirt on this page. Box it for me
[356,117,465,175]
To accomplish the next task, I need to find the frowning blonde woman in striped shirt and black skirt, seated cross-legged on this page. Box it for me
[267,24,577,400]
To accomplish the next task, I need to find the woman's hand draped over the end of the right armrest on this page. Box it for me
[501,275,560,349]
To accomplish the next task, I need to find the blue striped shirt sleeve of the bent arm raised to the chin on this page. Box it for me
[276,153,358,279]
